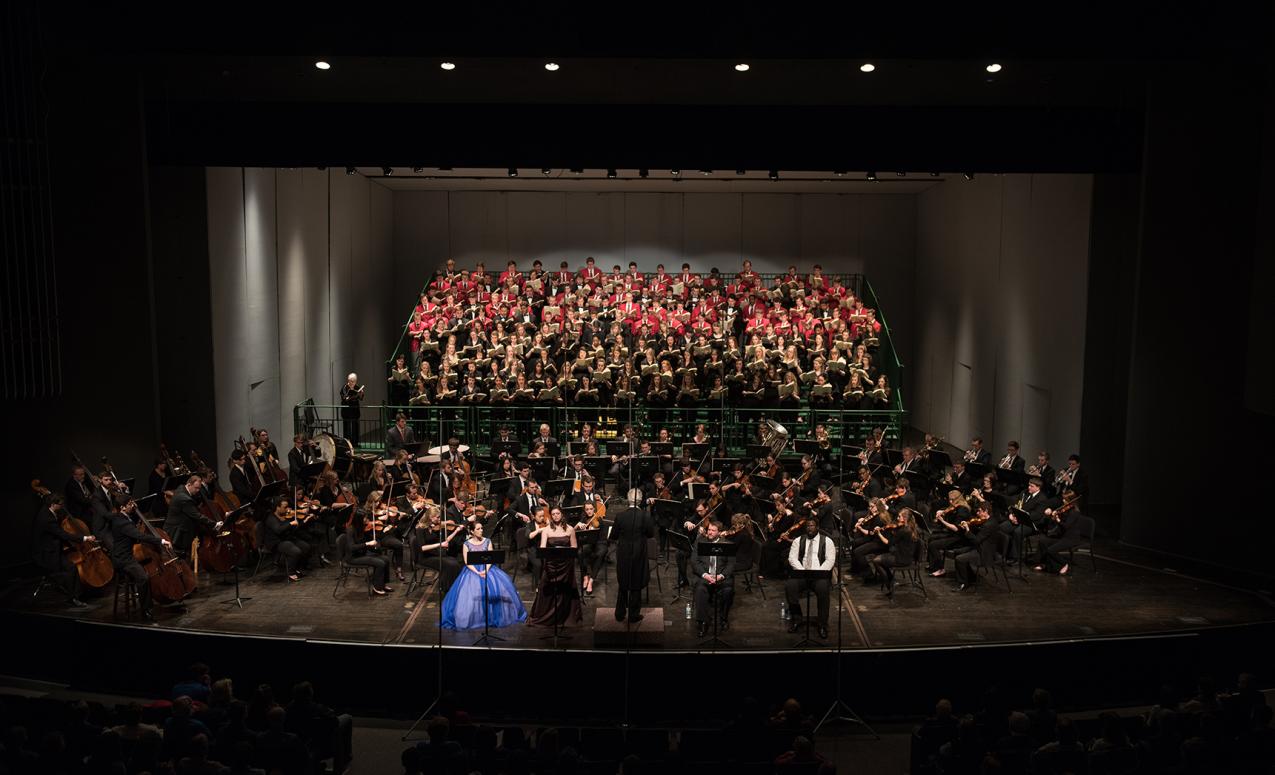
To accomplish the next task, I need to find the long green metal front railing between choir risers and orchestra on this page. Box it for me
[292,403,907,456]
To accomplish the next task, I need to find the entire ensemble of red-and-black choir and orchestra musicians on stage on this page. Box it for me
[17,259,1088,640]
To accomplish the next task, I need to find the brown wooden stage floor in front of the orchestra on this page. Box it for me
[0,542,1275,651]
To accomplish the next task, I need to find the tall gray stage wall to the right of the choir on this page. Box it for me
[909,175,1091,463]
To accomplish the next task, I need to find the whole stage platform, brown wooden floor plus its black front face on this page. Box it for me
[3,540,1275,716]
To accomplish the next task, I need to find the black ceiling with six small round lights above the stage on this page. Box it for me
[40,3,1271,172]
